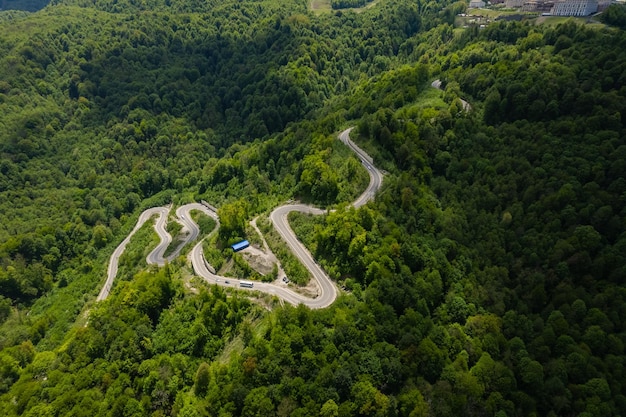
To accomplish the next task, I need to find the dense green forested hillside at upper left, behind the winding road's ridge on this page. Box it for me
[0,2,422,306]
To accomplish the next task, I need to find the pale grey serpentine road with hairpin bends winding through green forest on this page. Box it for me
[98,128,383,308]
